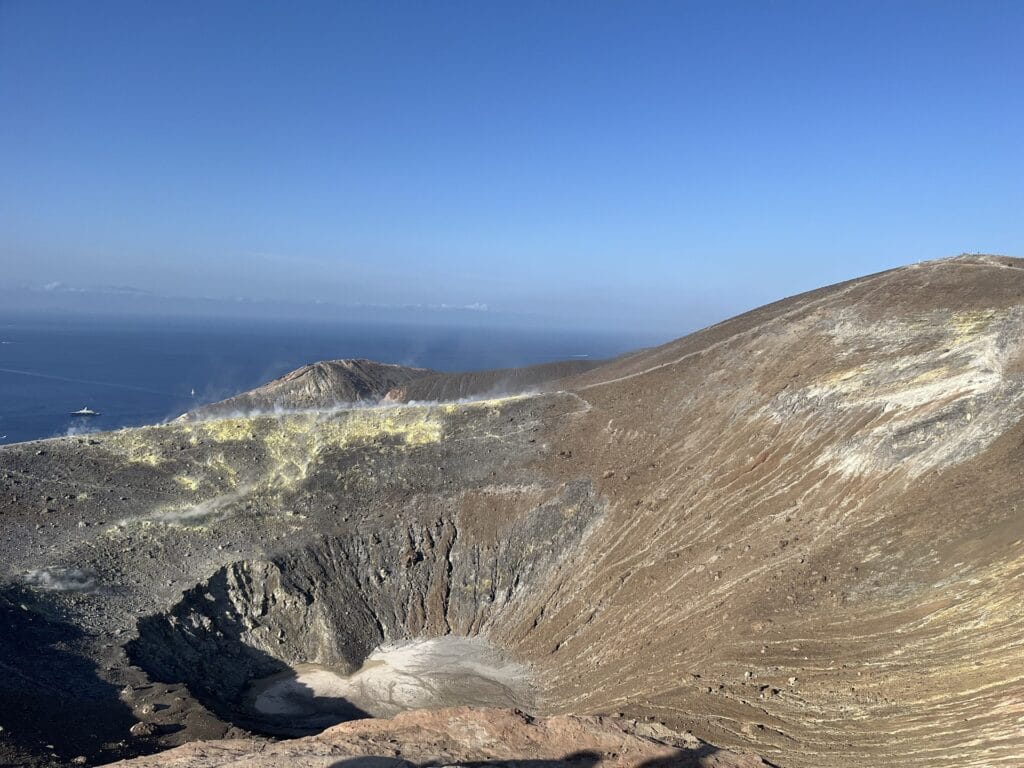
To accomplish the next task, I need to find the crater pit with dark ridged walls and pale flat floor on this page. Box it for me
[126,483,596,736]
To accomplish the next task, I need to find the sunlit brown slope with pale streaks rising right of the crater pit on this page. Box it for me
[536,257,1024,766]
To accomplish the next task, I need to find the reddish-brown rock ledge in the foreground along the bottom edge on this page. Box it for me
[101,709,767,768]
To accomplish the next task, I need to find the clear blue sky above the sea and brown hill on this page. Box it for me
[0,0,1024,335]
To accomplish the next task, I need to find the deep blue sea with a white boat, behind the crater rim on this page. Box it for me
[0,315,660,443]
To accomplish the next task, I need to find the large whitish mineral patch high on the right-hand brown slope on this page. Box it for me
[769,308,1024,477]
